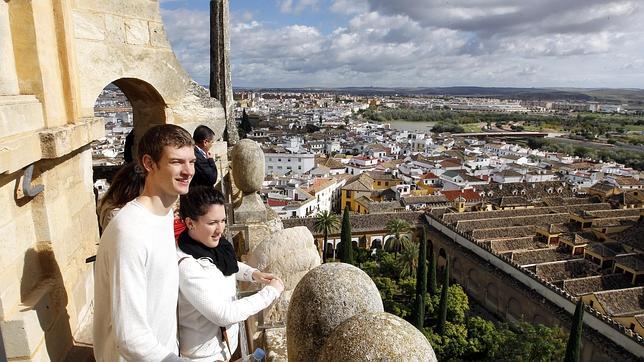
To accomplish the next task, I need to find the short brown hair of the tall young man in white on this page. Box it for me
[138,124,194,163]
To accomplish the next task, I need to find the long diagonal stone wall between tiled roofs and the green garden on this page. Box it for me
[427,217,641,361]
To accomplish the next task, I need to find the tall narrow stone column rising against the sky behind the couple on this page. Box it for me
[210,0,239,145]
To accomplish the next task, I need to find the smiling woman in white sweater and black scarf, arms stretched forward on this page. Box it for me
[178,186,284,362]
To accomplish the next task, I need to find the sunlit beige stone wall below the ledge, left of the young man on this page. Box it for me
[0,147,98,360]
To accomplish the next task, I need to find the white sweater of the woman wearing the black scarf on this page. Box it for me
[177,249,279,362]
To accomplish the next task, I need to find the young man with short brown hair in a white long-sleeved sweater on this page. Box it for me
[94,125,195,362]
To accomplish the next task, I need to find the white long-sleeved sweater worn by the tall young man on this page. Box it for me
[94,200,179,362]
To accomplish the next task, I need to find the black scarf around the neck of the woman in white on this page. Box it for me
[179,230,239,276]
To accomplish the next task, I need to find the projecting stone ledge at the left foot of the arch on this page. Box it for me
[39,117,105,158]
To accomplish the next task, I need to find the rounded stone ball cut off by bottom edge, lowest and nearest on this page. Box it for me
[318,312,437,362]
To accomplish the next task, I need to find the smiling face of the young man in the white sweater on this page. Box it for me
[147,146,195,197]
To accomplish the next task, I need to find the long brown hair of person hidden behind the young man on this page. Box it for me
[102,162,145,207]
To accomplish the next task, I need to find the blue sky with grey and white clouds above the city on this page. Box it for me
[161,0,644,88]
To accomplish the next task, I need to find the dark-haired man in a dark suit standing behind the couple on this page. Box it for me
[190,125,217,187]
